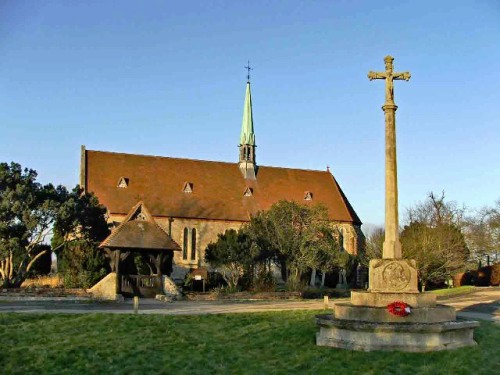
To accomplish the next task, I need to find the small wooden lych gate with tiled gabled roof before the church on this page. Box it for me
[99,202,181,297]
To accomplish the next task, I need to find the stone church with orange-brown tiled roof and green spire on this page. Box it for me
[80,81,363,280]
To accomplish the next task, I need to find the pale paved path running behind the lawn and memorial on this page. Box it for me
[0,288,500,323]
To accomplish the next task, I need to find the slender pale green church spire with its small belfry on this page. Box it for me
[238,62,257,180]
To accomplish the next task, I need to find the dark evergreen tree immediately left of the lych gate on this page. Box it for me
[52,186,109,288]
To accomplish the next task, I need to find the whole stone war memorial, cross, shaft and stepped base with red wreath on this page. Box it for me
[316,56,479,352]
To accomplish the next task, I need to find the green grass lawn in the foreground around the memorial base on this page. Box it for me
[0,311,500,375]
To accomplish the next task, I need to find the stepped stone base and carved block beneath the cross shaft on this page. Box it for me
[316,259,479,352]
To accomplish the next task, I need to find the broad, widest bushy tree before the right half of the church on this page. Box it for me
[248,201,340,289]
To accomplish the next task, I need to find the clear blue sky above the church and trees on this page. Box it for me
[0,0,500,228]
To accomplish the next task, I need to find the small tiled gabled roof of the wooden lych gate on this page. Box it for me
[99,202,181,250]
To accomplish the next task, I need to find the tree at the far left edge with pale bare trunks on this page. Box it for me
[0,162,65,287]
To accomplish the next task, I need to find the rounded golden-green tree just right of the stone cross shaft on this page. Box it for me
[401,193,469,290]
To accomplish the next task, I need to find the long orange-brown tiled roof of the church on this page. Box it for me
[85,150,361,224]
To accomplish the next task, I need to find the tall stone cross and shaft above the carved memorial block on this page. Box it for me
[368,56,411,259]
